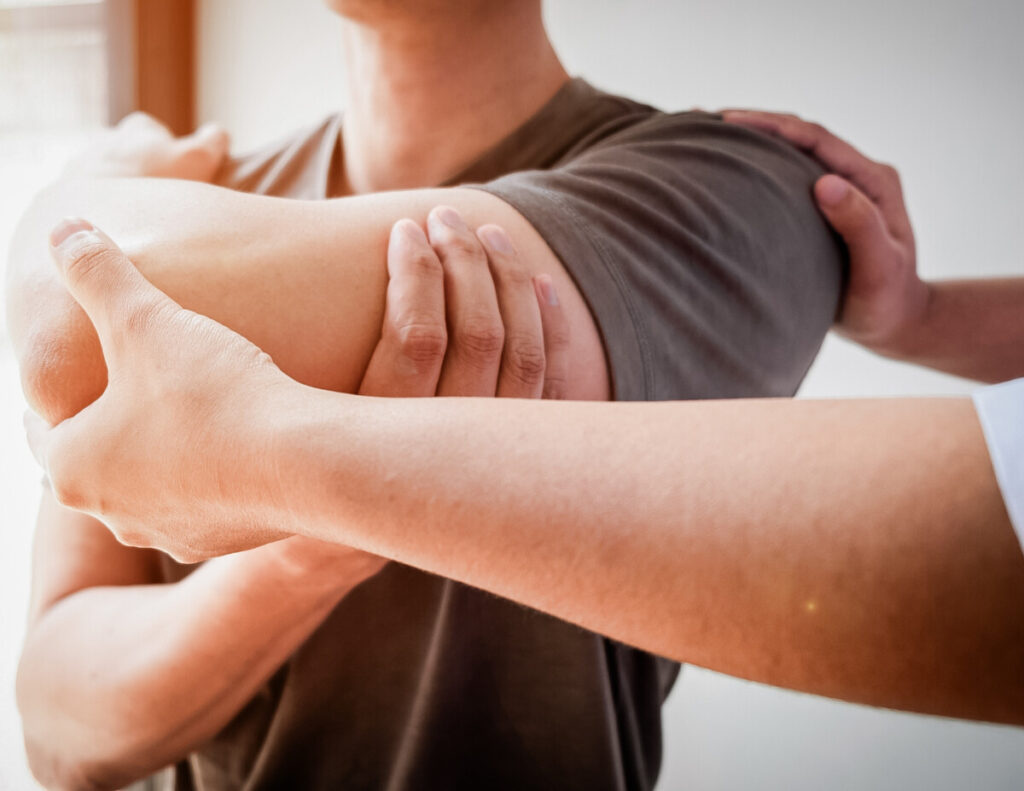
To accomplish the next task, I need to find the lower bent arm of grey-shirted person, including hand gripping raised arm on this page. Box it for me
[17,210,569,788]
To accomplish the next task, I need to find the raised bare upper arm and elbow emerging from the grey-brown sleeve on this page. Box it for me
[8,179,607,421]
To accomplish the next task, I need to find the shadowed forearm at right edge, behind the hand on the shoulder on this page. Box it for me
[886,278,1024,382]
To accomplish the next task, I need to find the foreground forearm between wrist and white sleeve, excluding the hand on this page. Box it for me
[280,392,1024,722]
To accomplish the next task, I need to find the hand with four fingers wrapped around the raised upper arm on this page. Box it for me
[266,207,569,573]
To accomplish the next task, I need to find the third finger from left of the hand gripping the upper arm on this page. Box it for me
[476,225,545,399]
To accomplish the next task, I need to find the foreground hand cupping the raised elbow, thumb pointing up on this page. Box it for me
[27,220,299,561]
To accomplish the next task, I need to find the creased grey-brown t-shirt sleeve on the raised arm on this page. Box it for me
[468,113,845,401]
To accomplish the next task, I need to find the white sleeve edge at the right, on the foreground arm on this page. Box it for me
[974,379,1024,548]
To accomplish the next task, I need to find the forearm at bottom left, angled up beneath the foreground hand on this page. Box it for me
[17,528,356,788]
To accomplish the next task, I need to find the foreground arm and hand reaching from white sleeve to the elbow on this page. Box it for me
[24,232,1024,724]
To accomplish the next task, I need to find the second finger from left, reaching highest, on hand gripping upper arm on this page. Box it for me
[427,206,505,396]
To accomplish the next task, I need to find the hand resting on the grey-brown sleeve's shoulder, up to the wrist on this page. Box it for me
[722,110,930,357]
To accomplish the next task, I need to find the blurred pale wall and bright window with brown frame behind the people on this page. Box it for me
[0,0,1024,791]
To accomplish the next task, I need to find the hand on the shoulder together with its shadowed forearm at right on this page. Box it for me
[723,111,1024,382]
